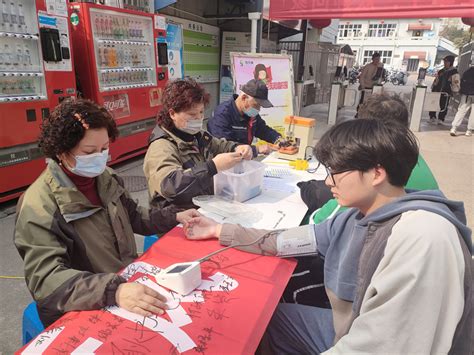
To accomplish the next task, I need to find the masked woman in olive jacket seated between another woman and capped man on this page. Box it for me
[143,79,253,208]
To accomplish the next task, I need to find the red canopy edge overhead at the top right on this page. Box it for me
[269,0,474,20]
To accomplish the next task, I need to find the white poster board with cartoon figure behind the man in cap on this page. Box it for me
[230,52,295,135]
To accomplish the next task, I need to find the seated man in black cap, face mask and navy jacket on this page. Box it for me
[207,79,282,155]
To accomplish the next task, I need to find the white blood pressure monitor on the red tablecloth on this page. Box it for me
[155,261,201,295]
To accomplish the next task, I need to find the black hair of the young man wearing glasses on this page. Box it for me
[314,119,419,187]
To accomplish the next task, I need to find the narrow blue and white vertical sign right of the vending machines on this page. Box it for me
[166,23,184,80]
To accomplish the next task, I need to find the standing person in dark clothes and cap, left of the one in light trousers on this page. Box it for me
[429,55,458,124]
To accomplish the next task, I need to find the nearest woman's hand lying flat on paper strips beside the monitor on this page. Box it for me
[115,282,168,317]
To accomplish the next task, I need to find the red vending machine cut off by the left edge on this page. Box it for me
[0,0,76,202]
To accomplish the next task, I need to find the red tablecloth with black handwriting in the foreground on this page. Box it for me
[18,227,295,354]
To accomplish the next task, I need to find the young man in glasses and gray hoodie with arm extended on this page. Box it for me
[181,119,472,354]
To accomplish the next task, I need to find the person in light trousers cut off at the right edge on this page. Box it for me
[449,63,474,137]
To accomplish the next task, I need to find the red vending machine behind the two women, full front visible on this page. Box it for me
[69,3,167,164]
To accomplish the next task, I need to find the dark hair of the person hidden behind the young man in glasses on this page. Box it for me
[358,94,408,126]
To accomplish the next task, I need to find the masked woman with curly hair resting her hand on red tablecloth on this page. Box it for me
[15,100,199,326]
